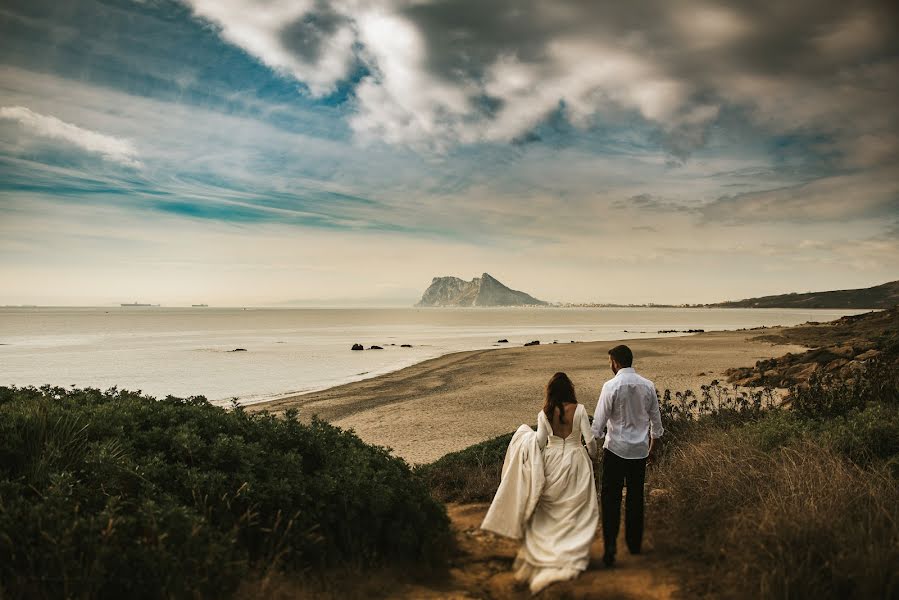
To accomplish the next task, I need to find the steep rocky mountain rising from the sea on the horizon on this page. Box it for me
[415,273,548,306]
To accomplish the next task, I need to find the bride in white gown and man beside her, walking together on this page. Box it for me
[481,345,664,594]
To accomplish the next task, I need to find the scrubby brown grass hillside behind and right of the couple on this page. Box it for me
[426,313,899,600]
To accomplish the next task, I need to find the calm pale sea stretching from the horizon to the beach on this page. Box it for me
[0,307,865,403]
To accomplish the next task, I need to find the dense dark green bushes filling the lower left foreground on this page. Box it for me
[0,387,449,598]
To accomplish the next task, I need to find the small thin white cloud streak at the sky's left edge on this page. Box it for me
[0,106,141,168]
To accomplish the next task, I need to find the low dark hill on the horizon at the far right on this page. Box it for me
[709,281,899,309]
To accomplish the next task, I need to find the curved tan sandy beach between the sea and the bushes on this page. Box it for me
[253,328,805,463]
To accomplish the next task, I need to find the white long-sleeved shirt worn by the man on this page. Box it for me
[592,367,665,458]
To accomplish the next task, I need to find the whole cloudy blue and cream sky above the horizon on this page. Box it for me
[0,0,899,306]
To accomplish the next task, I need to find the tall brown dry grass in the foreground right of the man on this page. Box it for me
[653,431,899,599]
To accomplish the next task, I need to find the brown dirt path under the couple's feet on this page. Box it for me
[389,504,678,600]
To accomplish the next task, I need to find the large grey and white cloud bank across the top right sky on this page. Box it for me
[185,0,899,164]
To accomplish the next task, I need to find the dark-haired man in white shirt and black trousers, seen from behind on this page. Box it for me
[593,345,665,567]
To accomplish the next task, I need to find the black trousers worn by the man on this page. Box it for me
[599,450,646,556]
